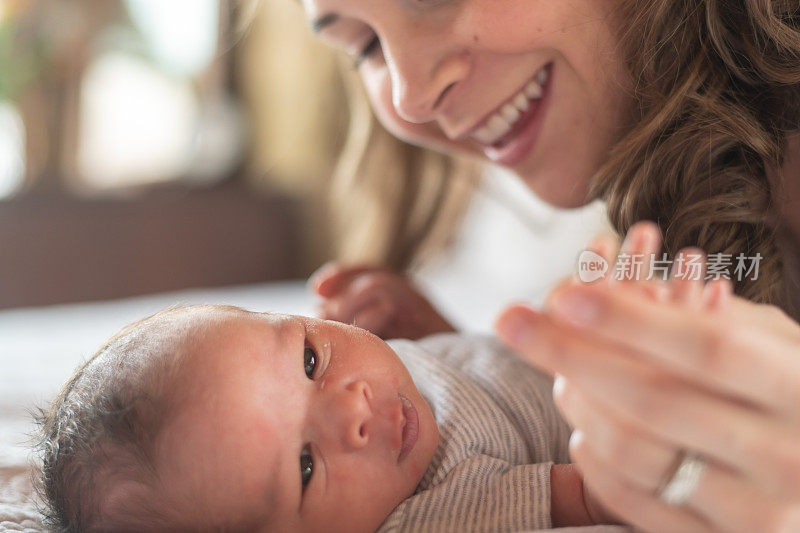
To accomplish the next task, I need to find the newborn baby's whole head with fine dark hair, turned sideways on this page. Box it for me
[36,306,438,531]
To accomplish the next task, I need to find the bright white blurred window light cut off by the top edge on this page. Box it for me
[125,0,220,76]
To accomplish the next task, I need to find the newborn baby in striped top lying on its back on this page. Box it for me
[34,306,616,532]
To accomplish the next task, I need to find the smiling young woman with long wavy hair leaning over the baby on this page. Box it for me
[303,0,800,532]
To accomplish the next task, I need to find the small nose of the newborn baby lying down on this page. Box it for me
[329,381,372,449]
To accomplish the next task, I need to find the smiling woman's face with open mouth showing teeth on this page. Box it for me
[303,0,632,207]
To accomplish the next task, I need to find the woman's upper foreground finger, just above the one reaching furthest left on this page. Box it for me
[547,285,800,418]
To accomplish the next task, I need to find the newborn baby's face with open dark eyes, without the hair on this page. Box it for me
[158,312,438,531]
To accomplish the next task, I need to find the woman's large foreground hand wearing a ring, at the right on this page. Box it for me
[498,224,800,532]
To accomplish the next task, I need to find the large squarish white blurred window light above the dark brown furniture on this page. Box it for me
[78,52,200,189]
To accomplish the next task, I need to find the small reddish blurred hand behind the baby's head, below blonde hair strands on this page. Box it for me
[309,263,455,339]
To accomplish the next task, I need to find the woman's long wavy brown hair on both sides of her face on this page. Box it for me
[336,0,800,316]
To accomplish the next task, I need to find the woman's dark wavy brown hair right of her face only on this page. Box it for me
[590,0,800,314]
